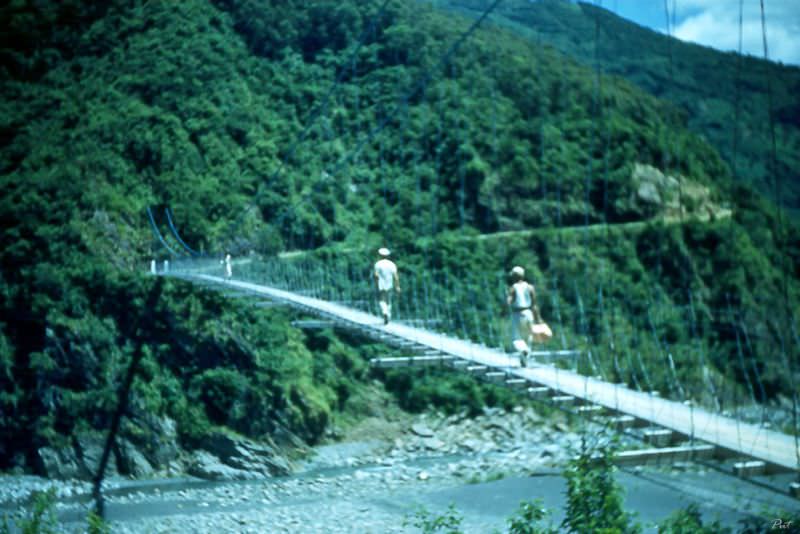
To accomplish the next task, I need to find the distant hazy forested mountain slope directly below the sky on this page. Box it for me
[435,0,800,216]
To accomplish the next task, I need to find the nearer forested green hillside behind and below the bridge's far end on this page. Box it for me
[0,0,800,478]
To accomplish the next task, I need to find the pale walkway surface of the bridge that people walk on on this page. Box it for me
[188,274,800,471]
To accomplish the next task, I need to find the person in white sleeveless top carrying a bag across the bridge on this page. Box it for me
[506,265,553,367]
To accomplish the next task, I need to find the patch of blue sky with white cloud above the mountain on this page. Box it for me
[608,0,800,65]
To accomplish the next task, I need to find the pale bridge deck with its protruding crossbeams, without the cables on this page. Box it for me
[161,268,800,494]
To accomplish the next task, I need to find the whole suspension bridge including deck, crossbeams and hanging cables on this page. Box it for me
[147,1,800,504]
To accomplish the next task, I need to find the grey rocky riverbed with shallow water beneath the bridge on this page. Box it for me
[0,408,791,533]
